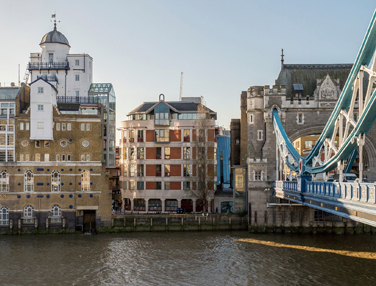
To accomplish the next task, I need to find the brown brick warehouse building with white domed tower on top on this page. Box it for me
[0,23,115,232]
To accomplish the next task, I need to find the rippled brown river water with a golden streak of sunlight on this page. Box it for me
[0,232,376,286]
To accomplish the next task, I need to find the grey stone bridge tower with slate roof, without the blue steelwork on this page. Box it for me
[241,64,376,231]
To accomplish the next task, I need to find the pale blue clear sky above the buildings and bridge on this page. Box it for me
[0,0,376,134]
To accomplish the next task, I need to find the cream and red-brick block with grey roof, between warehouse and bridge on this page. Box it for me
[120,95,217,212]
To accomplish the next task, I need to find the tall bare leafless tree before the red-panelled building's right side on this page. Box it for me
[189,98,216,212]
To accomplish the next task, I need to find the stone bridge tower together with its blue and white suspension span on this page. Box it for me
[240,8,376,230]
